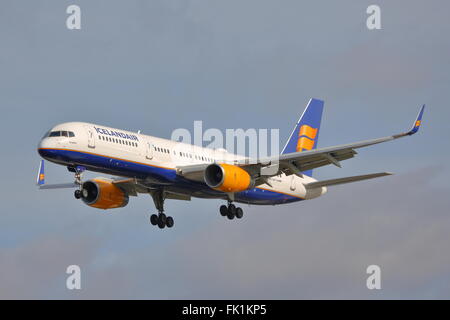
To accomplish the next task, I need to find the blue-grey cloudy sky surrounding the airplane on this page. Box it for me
[0,0,450,299]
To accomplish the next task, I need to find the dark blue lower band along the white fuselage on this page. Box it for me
[38,148,303,205]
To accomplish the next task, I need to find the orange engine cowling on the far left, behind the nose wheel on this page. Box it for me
[81,179,128,209]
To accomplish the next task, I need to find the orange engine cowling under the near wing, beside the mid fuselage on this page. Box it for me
[204,163,254,192]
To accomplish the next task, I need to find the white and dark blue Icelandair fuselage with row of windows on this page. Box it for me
[38,122,326,204]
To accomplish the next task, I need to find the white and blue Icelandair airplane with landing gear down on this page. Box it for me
[37,99,425,229]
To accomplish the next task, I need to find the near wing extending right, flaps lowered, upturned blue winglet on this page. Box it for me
[177,105,425,184]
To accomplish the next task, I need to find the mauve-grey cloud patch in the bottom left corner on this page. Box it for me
[0,233,99,299]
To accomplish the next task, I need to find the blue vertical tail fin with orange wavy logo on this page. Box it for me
[281,99,324,176]
